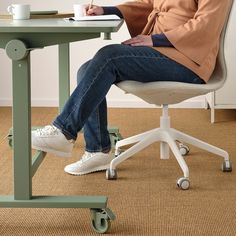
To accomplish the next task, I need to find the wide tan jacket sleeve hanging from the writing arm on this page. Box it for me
[116,0,153,37]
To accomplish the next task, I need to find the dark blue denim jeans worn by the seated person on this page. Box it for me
[53,44,204,152]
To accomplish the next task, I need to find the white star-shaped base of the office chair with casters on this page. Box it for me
[107,105,232,189]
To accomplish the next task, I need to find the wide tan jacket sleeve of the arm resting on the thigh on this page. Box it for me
[164,0,231,65]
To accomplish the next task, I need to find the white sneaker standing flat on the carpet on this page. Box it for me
[64,152,113,175]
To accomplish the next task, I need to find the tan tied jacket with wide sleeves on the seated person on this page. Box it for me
[117,0,230,81]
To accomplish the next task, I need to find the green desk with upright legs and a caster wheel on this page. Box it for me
[0,19,123,233]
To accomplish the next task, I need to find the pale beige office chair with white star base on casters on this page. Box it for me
[106,0,232,190]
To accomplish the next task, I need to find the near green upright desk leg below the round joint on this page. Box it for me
[12,49,32,200]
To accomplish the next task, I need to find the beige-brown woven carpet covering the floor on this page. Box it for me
[0,108,236,236]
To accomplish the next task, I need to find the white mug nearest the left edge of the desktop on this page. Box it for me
[7,4,30,20]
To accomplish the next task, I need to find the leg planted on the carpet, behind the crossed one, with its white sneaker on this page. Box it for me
[58,61,112,175]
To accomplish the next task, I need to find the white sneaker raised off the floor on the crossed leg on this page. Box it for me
[31,125,74,157]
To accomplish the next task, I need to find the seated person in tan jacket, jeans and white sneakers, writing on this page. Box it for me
[32,0,230,175]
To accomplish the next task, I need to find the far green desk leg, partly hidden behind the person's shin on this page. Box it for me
[58,43,70,112]
